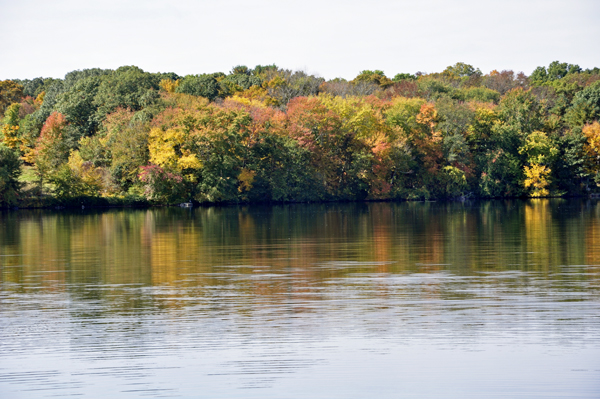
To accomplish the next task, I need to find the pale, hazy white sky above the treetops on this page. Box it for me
[0,0,600,79]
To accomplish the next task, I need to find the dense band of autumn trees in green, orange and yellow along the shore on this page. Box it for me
[0,61,600,207]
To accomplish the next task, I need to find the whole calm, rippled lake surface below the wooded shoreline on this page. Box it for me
[0,200,600,399]
